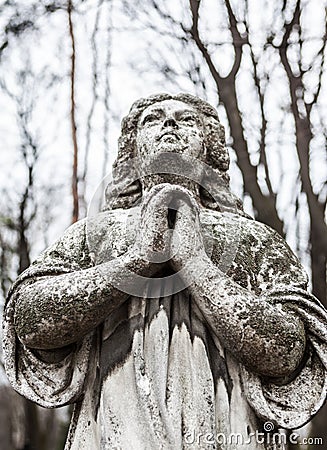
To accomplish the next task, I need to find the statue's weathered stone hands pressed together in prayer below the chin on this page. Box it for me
[135,183,207,271]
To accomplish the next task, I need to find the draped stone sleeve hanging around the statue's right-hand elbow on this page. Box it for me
[242,225,327,429]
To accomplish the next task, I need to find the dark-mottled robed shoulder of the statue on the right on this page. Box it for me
[200,210,307,295]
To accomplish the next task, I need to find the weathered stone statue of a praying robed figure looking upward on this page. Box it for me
[4,94,327,450]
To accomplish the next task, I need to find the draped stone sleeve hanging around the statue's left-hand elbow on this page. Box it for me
[3,221,96,408]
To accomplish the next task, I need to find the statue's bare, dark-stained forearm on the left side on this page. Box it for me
[14,255,154,349]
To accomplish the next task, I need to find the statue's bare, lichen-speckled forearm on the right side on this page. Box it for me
[186,258,305,377]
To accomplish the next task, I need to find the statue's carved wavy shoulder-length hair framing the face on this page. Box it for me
[104,93,244,214]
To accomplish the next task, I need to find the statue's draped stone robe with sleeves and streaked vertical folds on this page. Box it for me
[4,209,327,450]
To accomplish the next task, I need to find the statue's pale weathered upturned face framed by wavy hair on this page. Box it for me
[136,100,204,158]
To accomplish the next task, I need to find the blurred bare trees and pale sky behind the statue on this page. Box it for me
[0,0,327,450]
